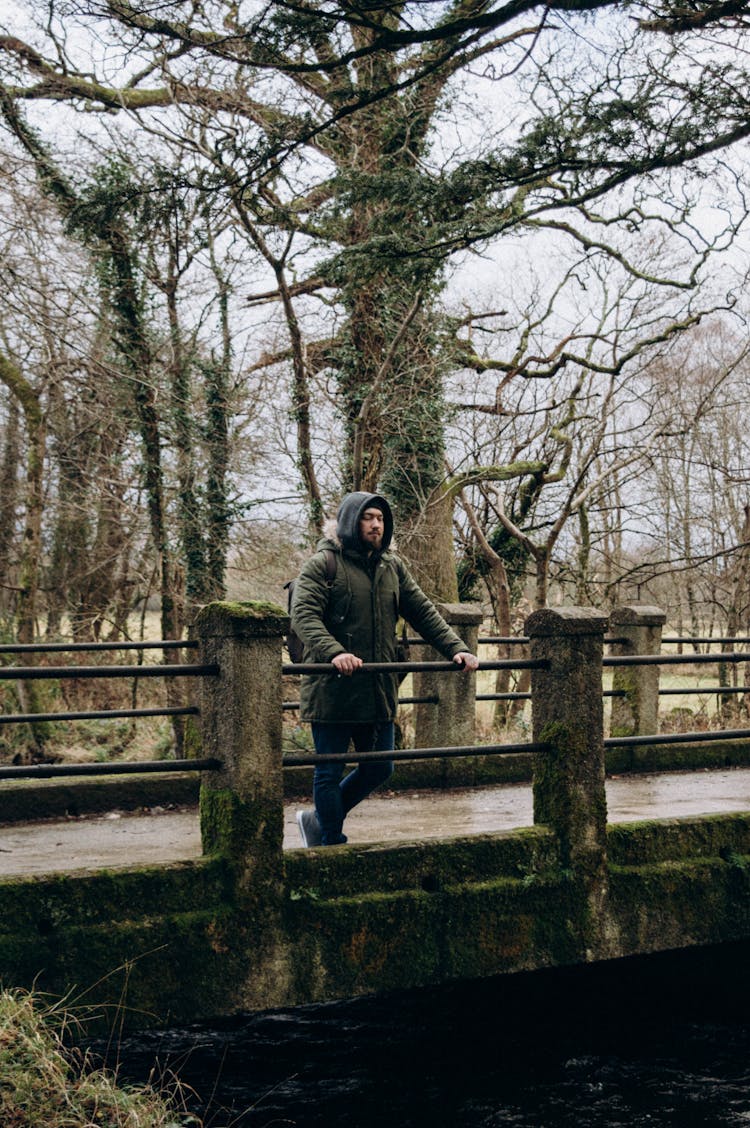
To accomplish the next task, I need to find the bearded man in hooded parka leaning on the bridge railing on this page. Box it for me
[291,492,478,846]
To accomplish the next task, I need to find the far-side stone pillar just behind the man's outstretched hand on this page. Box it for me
[409,603,484,774]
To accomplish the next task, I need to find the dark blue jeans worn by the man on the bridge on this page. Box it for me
[312,721,395,846]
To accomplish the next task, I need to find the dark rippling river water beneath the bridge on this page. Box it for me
[96,945,750,1128]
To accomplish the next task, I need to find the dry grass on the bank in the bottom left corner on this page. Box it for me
[0,990,200,1128]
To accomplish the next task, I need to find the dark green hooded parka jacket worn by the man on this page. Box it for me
[291,492,468,724]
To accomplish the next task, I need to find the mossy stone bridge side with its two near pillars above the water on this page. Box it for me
[0,603,750,1025]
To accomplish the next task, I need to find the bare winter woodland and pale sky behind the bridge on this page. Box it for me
[0,0,750,758]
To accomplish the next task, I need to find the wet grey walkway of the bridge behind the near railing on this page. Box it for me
[0,768,750,878]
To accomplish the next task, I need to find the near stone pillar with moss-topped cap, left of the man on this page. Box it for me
[194,602,289,898]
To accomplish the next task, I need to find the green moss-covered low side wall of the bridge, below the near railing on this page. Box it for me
[0,780,750,1025]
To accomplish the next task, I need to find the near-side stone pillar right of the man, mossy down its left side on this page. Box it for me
[526,607,608,954]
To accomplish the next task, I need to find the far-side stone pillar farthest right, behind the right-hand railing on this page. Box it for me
[609,603,667,756]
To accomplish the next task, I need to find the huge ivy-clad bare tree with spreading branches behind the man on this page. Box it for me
[2,0,748,598]
